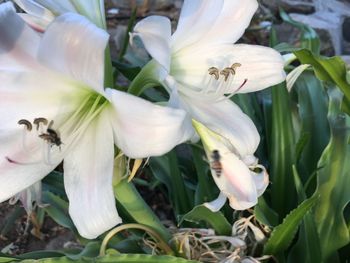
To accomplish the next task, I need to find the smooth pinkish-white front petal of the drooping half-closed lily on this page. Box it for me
[212,153,258,210]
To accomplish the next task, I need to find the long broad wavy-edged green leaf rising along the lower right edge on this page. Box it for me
[314,88,350,262]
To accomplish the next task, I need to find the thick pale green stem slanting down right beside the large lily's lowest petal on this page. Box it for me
[114,179,172,245]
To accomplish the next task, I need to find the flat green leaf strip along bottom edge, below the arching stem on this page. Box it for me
[95,254,199,263]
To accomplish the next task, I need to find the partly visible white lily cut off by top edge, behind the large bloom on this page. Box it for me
[14,0,106,32]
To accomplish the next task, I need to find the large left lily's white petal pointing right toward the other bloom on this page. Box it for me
[106,89,192,159]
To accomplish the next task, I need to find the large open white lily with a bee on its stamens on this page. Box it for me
[0,3,190,238]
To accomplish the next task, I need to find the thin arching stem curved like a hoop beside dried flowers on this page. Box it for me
[100,224,174,256]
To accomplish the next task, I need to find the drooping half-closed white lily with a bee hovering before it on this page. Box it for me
[193,120,269,211]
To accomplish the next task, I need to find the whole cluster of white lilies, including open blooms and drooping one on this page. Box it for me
[0,0,285,238]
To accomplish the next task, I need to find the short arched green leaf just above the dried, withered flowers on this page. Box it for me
[179,205,232,236]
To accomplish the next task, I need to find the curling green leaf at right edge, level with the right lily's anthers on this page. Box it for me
[294,49,350,115]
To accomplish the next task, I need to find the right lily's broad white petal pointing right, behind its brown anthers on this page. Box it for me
[172,44,285,93]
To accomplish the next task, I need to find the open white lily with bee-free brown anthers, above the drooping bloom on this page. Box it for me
[131,0,285,159]
